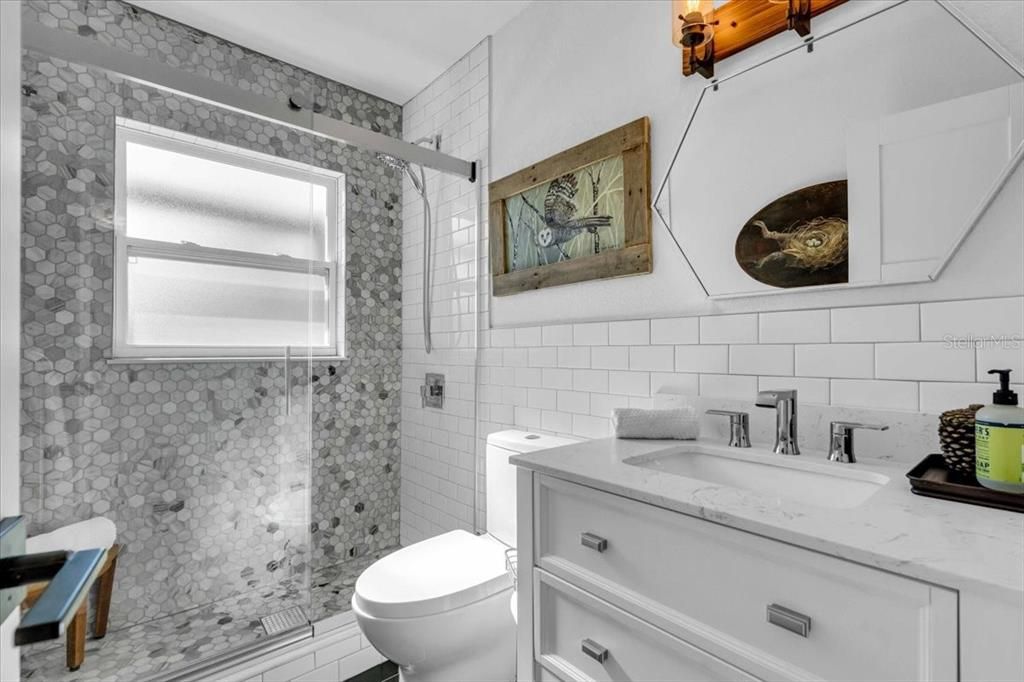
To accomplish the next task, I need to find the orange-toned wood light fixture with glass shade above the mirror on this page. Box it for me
[672,0,846,79]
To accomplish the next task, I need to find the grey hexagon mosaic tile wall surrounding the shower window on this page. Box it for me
[22,0,401,627]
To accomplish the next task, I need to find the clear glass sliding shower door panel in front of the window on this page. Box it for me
[22,45,321,680]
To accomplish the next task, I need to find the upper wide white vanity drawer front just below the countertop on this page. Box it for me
[535,475,957,681]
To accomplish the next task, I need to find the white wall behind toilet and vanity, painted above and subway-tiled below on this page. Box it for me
[401,0,1024,543]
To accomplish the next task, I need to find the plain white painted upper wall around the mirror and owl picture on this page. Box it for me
[492,0,1024,327]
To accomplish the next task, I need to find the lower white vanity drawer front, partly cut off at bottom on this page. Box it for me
[534,569,755,682]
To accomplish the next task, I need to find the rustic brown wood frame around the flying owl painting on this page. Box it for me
[488,117,652,296]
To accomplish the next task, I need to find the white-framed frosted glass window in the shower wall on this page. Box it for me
[114,121,344,359]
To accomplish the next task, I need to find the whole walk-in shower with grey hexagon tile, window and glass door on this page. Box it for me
[22,0,479,680]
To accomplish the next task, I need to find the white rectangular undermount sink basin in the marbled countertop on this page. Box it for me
[624,443,889,509]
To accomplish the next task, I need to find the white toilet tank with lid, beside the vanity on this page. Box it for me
[484,431,580,547]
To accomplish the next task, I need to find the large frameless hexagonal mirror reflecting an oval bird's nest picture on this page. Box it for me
[654,2,1024,297]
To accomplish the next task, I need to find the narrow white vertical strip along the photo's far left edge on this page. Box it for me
[0,2,22,680]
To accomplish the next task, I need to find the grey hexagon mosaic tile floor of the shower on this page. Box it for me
[22,548,397,682]
